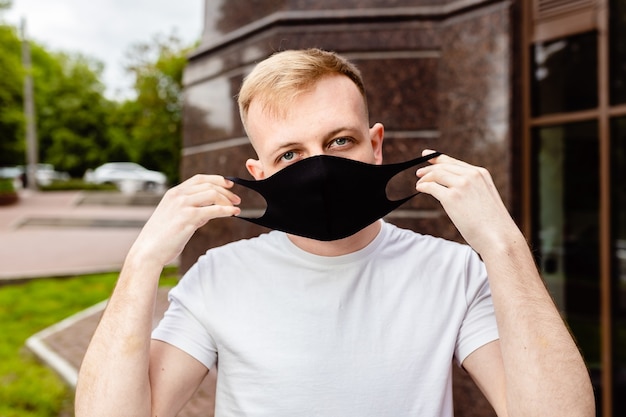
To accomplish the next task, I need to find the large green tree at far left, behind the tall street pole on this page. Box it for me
[0,17,115,176]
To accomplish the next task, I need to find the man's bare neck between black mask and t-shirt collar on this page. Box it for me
[287,220,382,256]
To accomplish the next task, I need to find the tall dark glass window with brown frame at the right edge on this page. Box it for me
[522,0,626,417]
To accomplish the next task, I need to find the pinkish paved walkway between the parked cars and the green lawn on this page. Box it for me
[0,190,154,280]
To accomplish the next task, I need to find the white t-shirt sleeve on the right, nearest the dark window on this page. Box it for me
[455,248,499,365]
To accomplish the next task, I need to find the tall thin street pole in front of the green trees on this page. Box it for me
[21,18,38,190]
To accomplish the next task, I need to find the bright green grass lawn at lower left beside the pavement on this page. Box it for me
[0,268,177,417]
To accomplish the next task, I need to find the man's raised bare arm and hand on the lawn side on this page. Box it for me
[76,175,240,417]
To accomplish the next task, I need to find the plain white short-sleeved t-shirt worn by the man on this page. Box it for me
[153,222,498,417]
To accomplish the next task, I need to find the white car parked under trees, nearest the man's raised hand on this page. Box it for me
[83,162,167,192]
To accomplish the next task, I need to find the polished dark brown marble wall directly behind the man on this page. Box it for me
[181,0,516,416]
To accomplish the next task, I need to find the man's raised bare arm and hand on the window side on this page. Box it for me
[417,151,595,417]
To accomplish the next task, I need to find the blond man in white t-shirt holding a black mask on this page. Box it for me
[76,49,595,417]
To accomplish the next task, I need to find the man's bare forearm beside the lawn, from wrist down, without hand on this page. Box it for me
[76,255,161,417]
